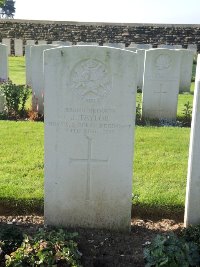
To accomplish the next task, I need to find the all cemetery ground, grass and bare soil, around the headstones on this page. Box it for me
[0,57,197,267]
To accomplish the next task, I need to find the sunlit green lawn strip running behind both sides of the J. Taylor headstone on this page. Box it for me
[0,121,190,218]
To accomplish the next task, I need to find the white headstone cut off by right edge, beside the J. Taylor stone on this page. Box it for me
[184,55,200,226]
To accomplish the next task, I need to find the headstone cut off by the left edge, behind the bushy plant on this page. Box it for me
[0,44,8,112]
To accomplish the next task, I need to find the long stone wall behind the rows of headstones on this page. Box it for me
[0,19,200,51]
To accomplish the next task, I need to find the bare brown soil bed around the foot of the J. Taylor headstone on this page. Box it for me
[0,215,183,267]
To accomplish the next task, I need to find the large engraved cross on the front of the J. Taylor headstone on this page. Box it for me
[70,136,108,200]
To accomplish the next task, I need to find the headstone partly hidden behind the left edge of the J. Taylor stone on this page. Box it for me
[30,45,56,114]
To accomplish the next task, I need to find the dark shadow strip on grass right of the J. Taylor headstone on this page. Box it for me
[131,204,184,222]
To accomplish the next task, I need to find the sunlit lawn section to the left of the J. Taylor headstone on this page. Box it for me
[0,121,44,214]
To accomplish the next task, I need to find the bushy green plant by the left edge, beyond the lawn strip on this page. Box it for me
[0,80,31,117]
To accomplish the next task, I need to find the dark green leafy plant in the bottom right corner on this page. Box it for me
[144,233,200,267]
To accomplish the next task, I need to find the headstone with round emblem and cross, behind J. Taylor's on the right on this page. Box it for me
[142,48,181,120]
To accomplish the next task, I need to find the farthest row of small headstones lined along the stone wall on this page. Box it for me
[2,38,197,56]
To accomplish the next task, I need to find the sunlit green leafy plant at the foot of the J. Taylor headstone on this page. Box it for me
[6,229,81,267]
